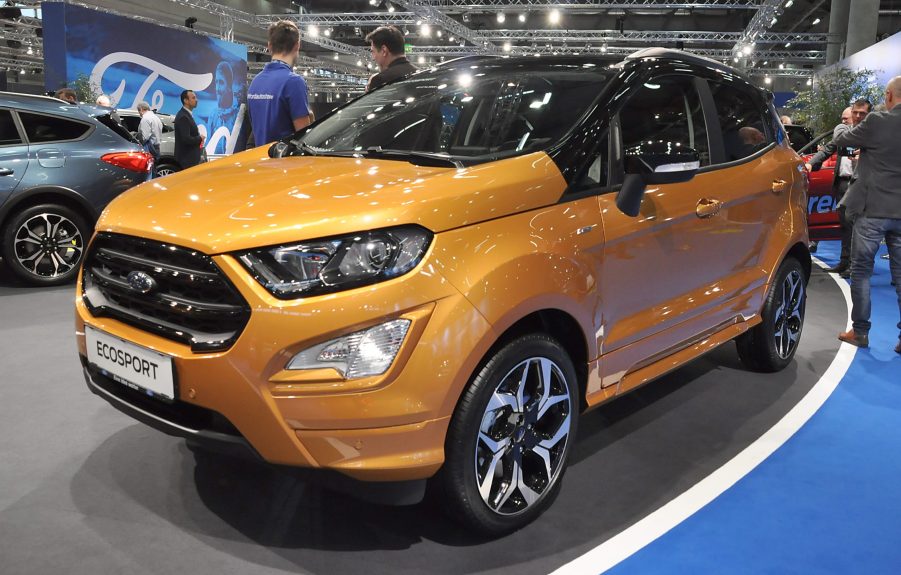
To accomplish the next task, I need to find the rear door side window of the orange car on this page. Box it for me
[710,82,771,162]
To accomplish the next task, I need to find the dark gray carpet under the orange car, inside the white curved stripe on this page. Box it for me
[0,271,847,575]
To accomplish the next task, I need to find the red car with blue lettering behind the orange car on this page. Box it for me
[798,131,842,241]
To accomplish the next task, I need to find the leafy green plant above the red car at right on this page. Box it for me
[785,68,885,134]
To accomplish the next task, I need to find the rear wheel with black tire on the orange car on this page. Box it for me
[735,257,807,372]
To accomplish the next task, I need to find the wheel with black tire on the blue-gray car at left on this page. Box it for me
[3,204,92,286]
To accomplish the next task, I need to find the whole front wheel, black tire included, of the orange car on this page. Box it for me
[434,334,580,537]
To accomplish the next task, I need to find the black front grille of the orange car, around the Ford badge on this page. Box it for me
[83,233,250,352]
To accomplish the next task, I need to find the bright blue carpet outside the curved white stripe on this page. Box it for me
[608,242,901,575]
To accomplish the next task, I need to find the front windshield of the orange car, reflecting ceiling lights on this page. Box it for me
[301,59,609,162]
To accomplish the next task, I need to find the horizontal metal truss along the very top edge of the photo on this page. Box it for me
[400,0,759,13]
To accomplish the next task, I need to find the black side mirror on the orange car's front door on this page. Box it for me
[616,142,701,217]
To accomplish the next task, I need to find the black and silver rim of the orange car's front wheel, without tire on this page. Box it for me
[475,357,573,515]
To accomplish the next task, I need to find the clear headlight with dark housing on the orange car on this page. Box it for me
[238,226,432,299]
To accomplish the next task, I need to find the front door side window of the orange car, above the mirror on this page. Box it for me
[619,76,710,166]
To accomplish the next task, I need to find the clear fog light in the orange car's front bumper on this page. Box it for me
[287,319,410,379]
